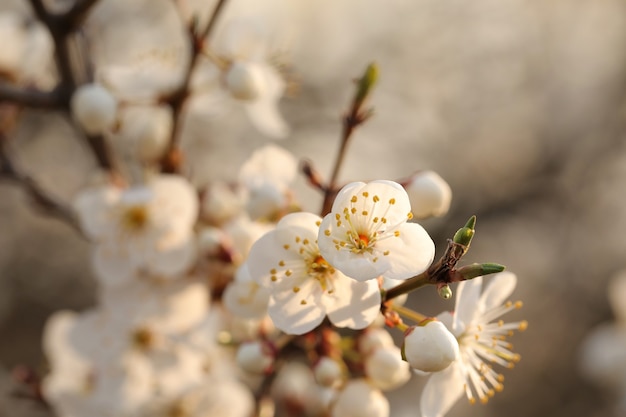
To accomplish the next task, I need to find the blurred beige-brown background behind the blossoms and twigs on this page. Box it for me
[0,0,626,417]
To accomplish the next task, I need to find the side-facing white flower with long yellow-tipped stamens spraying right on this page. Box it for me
[420,272,527,417]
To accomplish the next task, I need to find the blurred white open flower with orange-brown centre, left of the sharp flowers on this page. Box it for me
[76,175,198,285]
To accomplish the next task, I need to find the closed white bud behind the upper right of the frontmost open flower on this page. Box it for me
[405,171,452,219]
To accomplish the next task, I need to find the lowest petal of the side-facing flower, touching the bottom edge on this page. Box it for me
[420,363,465,417]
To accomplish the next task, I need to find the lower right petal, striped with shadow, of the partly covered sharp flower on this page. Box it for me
[328,272,380,329]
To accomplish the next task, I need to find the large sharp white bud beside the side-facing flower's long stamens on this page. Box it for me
[402,321,459,372]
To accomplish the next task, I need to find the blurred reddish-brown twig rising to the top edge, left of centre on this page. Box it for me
[161,0,227,172]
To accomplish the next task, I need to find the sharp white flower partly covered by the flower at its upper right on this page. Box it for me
[247,212,380,334]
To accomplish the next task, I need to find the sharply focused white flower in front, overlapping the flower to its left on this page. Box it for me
[318,180,435,281]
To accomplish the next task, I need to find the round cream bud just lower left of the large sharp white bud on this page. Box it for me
[365,346,411,390]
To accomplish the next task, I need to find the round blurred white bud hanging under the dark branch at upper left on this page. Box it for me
[70,84,117,135]
